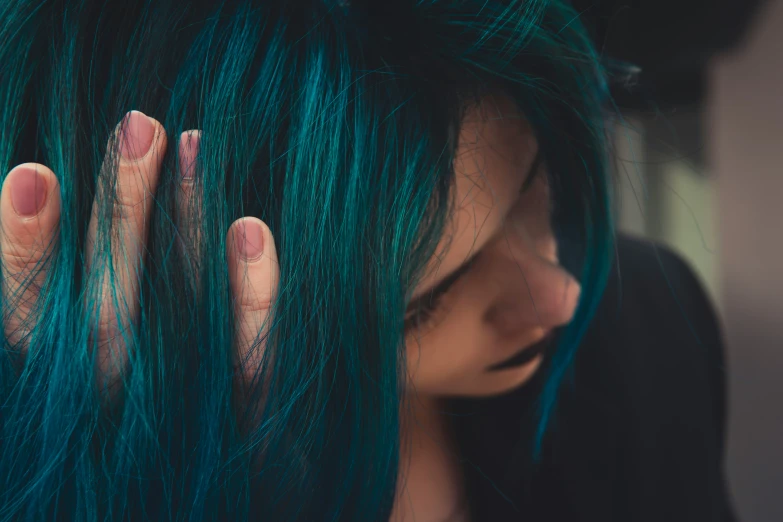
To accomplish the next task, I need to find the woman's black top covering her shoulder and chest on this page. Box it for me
[448,236,735,522]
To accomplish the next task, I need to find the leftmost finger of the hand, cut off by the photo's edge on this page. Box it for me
[0,163,60,354]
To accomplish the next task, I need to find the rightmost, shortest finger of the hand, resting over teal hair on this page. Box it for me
[227,213,280,384]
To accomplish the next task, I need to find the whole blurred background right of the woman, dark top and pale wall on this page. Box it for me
[573,0,783,522]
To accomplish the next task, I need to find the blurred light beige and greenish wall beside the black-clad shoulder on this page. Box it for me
[615,5,783,512]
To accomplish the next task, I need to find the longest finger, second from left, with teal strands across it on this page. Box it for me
[87,111,167,385]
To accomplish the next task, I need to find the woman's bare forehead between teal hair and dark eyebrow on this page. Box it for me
[414,96,538,297]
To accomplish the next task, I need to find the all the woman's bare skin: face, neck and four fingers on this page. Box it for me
[0,97,579,522]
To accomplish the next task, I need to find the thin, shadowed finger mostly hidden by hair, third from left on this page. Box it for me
[177,130,202,285]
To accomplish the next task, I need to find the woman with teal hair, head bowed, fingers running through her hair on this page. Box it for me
[0,0,728,521]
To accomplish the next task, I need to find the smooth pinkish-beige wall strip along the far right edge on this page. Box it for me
[707,0,783,522]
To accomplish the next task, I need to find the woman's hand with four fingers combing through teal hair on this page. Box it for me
[0,111,280,397]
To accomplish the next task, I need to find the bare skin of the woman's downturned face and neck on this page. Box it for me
[391,96,580,522]
